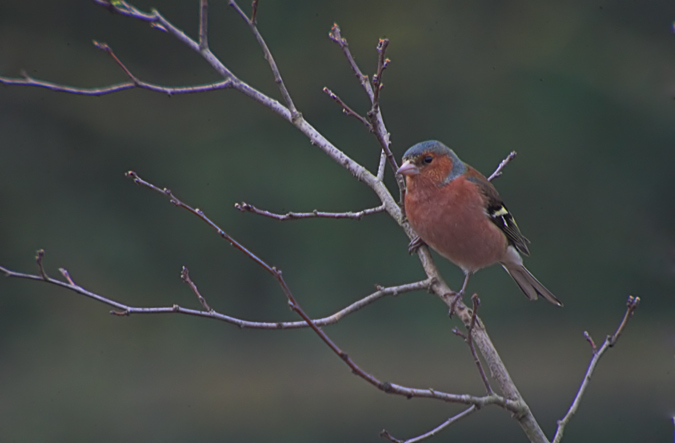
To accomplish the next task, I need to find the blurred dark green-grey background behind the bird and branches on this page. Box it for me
[0,0,675,442]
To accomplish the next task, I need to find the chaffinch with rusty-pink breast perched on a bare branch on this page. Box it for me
[396,140,563,306]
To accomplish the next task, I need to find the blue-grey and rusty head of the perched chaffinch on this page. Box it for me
[396,140,466,186]
